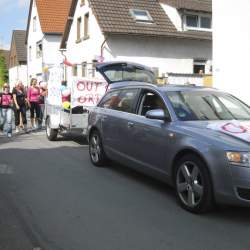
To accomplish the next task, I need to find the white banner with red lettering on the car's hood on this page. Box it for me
[207,120,250,142]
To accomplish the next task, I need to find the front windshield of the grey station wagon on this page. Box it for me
[166,91,250,121]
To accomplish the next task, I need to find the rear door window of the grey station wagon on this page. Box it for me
[116,89,138,113]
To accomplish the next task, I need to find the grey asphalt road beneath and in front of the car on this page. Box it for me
[0,132,250,250]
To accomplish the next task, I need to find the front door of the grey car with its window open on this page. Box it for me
[130,90,174,174]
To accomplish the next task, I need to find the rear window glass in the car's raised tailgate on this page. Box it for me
[100,64,156,83]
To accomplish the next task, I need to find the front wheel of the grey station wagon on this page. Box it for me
[175,154,214,214]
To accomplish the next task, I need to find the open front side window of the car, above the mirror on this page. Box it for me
[138,90,169,116]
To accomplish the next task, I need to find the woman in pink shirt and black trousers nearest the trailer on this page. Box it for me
[27,78,41,129]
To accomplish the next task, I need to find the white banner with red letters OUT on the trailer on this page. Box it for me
[71,78,108,108]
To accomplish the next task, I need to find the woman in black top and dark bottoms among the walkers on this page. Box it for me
[12,81,28,133]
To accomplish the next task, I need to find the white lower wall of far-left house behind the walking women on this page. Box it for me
[9,65,28,89]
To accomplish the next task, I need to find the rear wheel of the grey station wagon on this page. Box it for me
[89,130,108,167]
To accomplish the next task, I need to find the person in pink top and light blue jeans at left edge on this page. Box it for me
[0,83,13,138]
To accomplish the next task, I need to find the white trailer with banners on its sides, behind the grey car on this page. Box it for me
[45,66,107,141]
